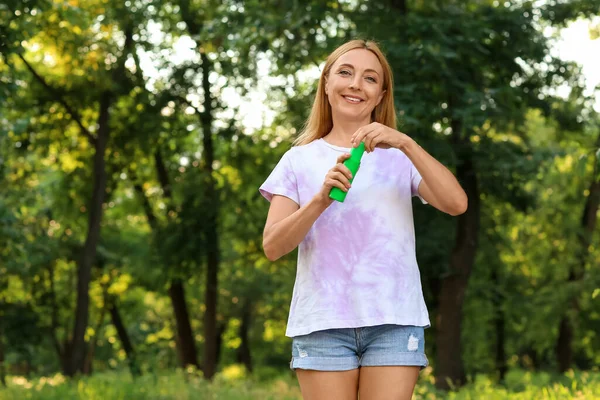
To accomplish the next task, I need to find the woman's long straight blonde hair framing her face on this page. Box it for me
[294,39,396,146]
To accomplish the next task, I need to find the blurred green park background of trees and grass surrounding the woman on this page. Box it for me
[0,0,600,399]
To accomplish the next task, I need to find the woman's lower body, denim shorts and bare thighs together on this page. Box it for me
[290,325,428,400]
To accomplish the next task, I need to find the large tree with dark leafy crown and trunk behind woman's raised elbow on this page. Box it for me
[353,2,588,388]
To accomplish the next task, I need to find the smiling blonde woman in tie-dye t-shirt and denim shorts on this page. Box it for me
[260,40,467,400]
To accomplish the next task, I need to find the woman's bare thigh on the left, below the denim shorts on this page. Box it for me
[296,369,362,400]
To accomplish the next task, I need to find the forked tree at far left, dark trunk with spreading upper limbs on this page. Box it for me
[1,2,146,375]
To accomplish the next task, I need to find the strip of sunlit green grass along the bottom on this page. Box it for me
[0,365,600,400]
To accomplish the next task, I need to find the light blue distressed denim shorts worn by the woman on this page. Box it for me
[290,325,429,371]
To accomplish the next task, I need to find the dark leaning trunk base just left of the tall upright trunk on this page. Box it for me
[169,279,199,368]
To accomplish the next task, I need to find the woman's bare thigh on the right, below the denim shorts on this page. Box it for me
[358,366,421,400]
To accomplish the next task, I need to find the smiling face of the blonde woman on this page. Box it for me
[325,49,385,122]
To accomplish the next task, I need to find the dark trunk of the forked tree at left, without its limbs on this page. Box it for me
[65,92,112,376]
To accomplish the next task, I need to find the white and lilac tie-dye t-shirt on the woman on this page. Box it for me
[259,139,430,337]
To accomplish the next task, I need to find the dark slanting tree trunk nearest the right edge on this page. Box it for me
[556,144,600,373]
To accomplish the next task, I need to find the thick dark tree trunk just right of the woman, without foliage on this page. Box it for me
[435,141,480,389]
